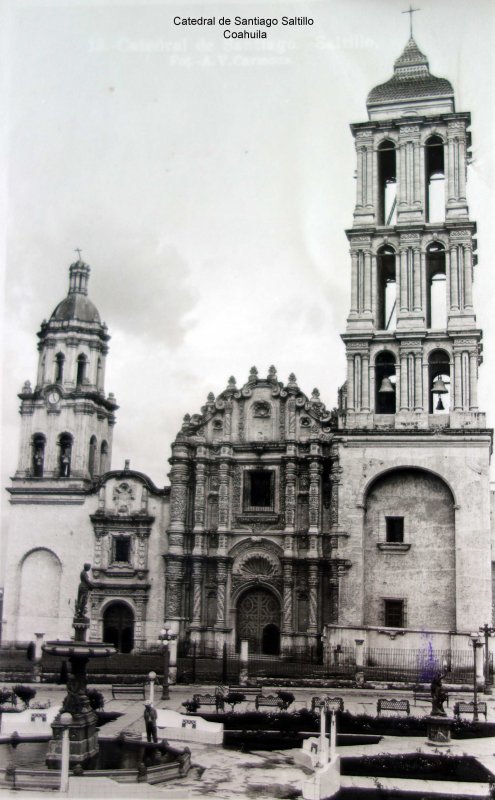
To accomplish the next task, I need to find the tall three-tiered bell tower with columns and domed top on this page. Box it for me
[341,34,485,429]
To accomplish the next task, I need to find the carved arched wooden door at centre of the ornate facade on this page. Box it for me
[237,589,280,655]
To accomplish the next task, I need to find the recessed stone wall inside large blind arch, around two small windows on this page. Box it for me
[363,471,456,630]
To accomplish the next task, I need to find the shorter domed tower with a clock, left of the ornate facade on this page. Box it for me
[14,258,118,482]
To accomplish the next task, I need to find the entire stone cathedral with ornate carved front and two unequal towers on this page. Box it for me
[3,37,492,657]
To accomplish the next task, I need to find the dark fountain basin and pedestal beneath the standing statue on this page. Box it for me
[43,617,115,769]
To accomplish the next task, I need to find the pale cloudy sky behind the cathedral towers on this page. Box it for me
[0,0,495,524]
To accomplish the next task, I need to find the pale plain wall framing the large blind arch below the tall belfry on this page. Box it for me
[339,431,492,632]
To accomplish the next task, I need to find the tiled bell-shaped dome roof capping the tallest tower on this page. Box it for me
[366,36,454,108]
